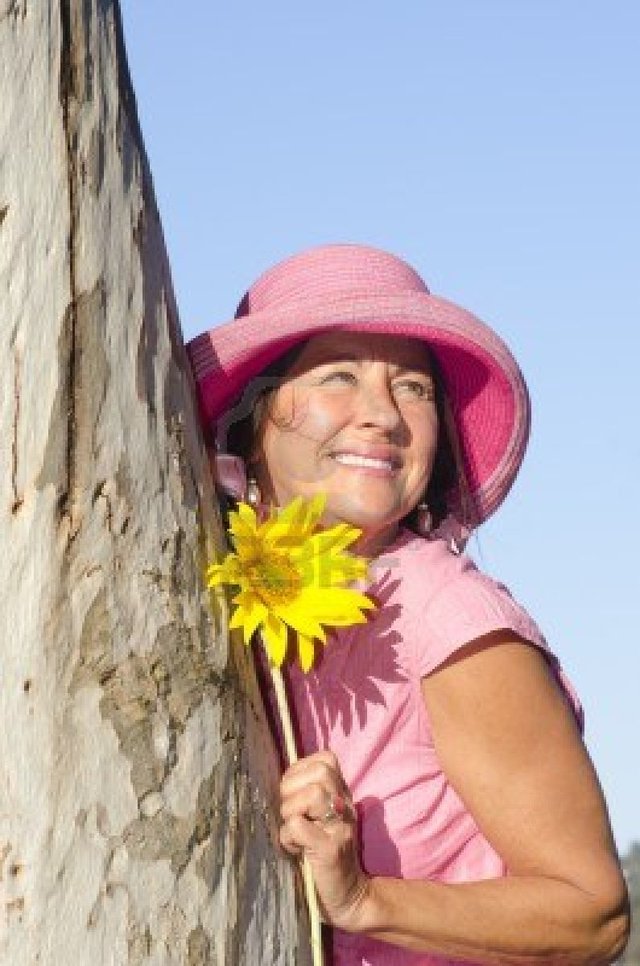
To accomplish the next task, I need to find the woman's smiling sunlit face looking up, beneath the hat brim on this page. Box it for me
[254,331,438,553]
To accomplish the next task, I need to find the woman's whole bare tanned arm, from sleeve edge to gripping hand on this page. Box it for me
[283,632,628,964]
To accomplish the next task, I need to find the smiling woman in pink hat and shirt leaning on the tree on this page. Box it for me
[189,245,628,966]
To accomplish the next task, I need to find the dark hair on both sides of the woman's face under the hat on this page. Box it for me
[220,342,476,530]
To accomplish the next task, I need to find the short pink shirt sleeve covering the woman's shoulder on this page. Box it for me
[417,556,583,728]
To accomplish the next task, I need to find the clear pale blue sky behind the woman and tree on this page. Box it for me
[121,0,640,850]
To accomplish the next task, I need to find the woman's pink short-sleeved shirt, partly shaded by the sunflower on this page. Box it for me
[287,530,581,966]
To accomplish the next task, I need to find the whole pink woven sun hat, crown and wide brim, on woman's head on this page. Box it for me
[187,245,530,526]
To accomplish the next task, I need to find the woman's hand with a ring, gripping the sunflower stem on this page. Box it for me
[280,751,369,929]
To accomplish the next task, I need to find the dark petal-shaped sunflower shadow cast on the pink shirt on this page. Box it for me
[309,573,407,744]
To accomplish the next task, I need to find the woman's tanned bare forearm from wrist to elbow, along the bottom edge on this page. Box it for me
[345,876,628,964]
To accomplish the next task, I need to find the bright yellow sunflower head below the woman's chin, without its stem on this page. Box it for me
[207,494,374,671]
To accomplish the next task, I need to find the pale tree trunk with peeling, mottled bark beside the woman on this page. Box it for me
[0,0,308,966]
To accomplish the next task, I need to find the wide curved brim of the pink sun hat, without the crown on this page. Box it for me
[187,292,530,524]
